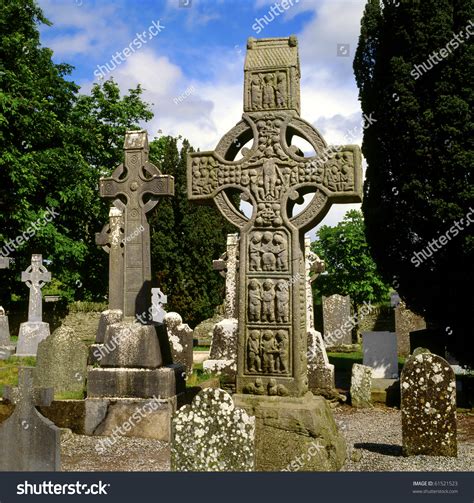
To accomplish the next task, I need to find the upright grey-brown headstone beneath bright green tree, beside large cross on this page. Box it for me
[323,293,352,347]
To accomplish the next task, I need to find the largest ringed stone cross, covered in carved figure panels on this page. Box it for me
[188,36,362,396]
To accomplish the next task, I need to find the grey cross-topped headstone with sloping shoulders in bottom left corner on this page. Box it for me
[0,368,61,472]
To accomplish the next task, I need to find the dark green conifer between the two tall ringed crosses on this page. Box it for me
[149,136,235,326]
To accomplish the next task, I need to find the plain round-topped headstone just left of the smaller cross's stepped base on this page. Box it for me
[34,326,88,393]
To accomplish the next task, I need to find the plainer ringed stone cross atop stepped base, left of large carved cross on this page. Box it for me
[100,130,174,319]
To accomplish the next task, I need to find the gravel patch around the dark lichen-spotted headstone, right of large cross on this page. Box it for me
[334,406,474,472]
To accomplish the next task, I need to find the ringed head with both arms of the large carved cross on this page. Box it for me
[188,114,362,228]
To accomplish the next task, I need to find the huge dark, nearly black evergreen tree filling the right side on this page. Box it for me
[354,0,474,364]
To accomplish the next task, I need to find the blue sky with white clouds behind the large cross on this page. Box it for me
[38,0,365,235]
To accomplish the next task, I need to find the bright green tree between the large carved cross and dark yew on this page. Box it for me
[311,210,390,306]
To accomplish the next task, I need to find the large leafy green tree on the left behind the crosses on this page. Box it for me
[0,0,152,300]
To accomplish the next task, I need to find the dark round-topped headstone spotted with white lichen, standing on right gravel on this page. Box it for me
[401,349,457,457]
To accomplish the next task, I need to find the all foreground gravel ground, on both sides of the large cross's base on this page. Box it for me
[61,406,474,472]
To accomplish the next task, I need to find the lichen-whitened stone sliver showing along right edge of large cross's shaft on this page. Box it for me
[304,237,336,394]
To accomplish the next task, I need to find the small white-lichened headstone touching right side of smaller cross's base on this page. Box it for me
[163,313,193,377]
